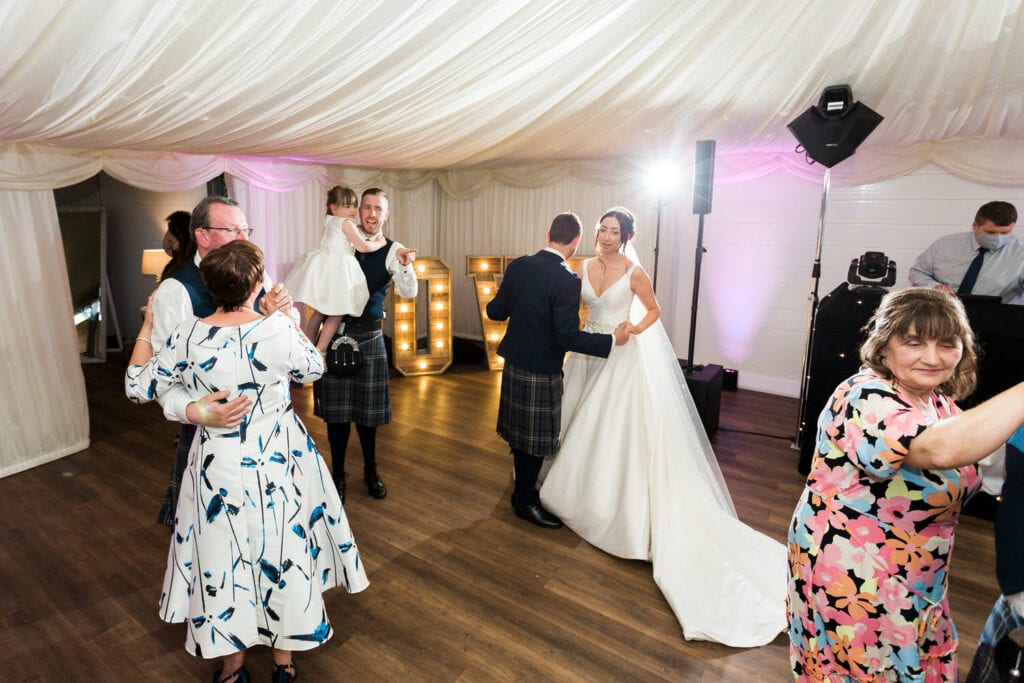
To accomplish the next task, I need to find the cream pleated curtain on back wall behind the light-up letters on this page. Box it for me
[228,165,634,339]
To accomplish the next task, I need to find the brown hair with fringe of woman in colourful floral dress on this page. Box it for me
[860,287,978,399]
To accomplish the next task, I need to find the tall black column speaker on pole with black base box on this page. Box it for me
[679,140,725,438]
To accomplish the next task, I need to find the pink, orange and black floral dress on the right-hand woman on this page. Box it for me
[788,371,980,681]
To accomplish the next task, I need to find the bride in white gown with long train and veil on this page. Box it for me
[541,208,787,647]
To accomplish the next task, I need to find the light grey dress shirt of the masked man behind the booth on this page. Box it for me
[909,232,1024,304]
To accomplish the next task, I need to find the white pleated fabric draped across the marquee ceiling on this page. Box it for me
[0,0,1024,181]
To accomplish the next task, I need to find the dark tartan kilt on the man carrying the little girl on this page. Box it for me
[313,330,391,427]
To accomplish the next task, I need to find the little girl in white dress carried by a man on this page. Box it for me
[285,185,386,353]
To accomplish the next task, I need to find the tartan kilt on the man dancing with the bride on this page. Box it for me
[498,364,562,456]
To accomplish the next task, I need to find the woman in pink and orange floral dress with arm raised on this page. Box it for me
[788,288,1024,681]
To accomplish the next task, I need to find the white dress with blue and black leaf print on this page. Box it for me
[125,313,369,657]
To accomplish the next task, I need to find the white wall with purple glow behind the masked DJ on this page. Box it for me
[659,166,1024,396]
